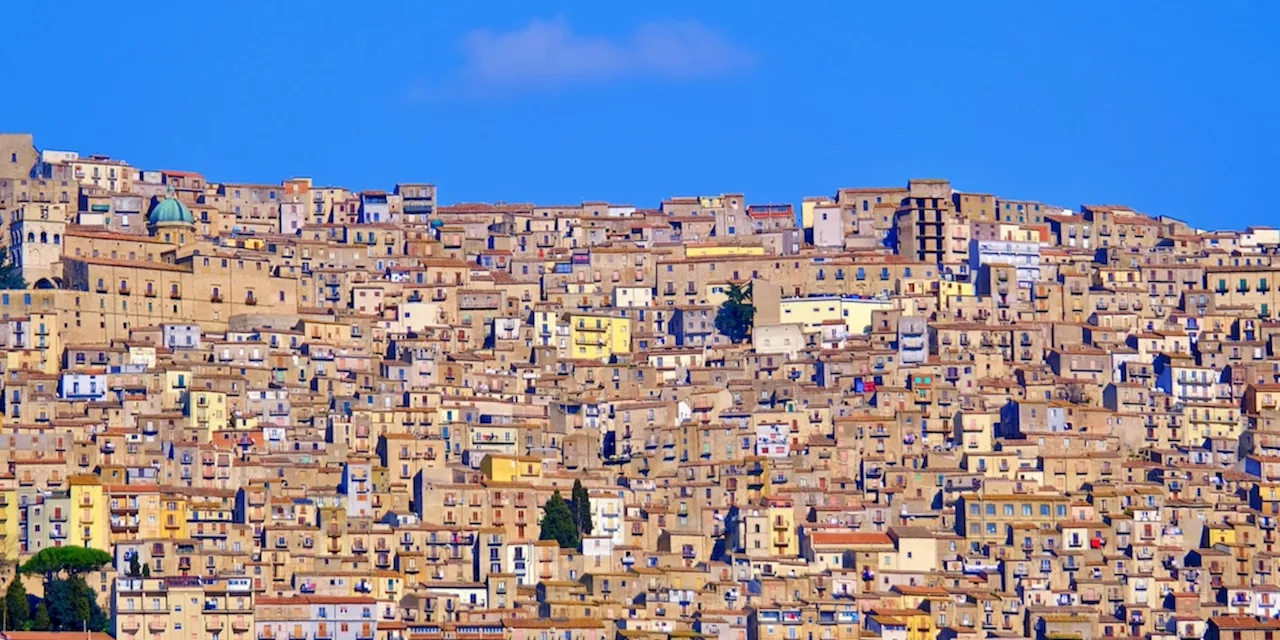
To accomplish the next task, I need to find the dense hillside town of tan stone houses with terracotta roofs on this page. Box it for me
[0,129,1280,640]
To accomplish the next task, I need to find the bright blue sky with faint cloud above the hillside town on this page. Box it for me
[0,0,1280,227]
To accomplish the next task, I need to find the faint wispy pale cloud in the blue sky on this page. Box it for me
[458,19,751,91]
